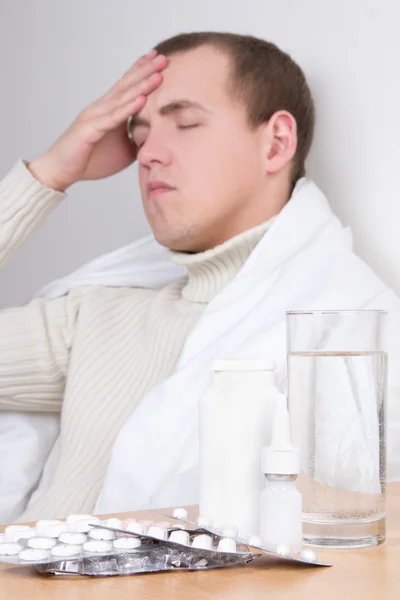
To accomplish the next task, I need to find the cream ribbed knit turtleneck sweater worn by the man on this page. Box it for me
[0,159,270,520]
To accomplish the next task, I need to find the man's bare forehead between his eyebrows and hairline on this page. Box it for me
[140,46,230,117]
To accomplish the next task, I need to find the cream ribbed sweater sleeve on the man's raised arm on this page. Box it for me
[0,159,79,418]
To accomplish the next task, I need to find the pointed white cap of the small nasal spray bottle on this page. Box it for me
[262,394,300,475]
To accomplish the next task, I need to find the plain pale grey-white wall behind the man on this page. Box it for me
[0,0,400,306]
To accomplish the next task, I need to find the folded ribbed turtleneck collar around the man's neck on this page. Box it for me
[168,217,276,303]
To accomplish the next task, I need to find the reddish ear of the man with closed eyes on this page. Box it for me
[264,110,297,173]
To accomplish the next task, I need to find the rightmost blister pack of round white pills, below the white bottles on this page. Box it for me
[164,508,332,567]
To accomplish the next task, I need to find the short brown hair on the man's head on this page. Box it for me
[155,31,315,183]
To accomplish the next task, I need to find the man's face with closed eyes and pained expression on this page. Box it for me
[133,46,265,252]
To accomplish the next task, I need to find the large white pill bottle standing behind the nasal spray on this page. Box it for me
[199,360,279,538]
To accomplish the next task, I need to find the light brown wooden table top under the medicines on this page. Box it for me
[0,483,400,600]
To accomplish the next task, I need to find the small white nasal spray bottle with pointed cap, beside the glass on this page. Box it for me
[260,394,303,554]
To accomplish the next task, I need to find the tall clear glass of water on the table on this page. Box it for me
[286,310,387,548]
